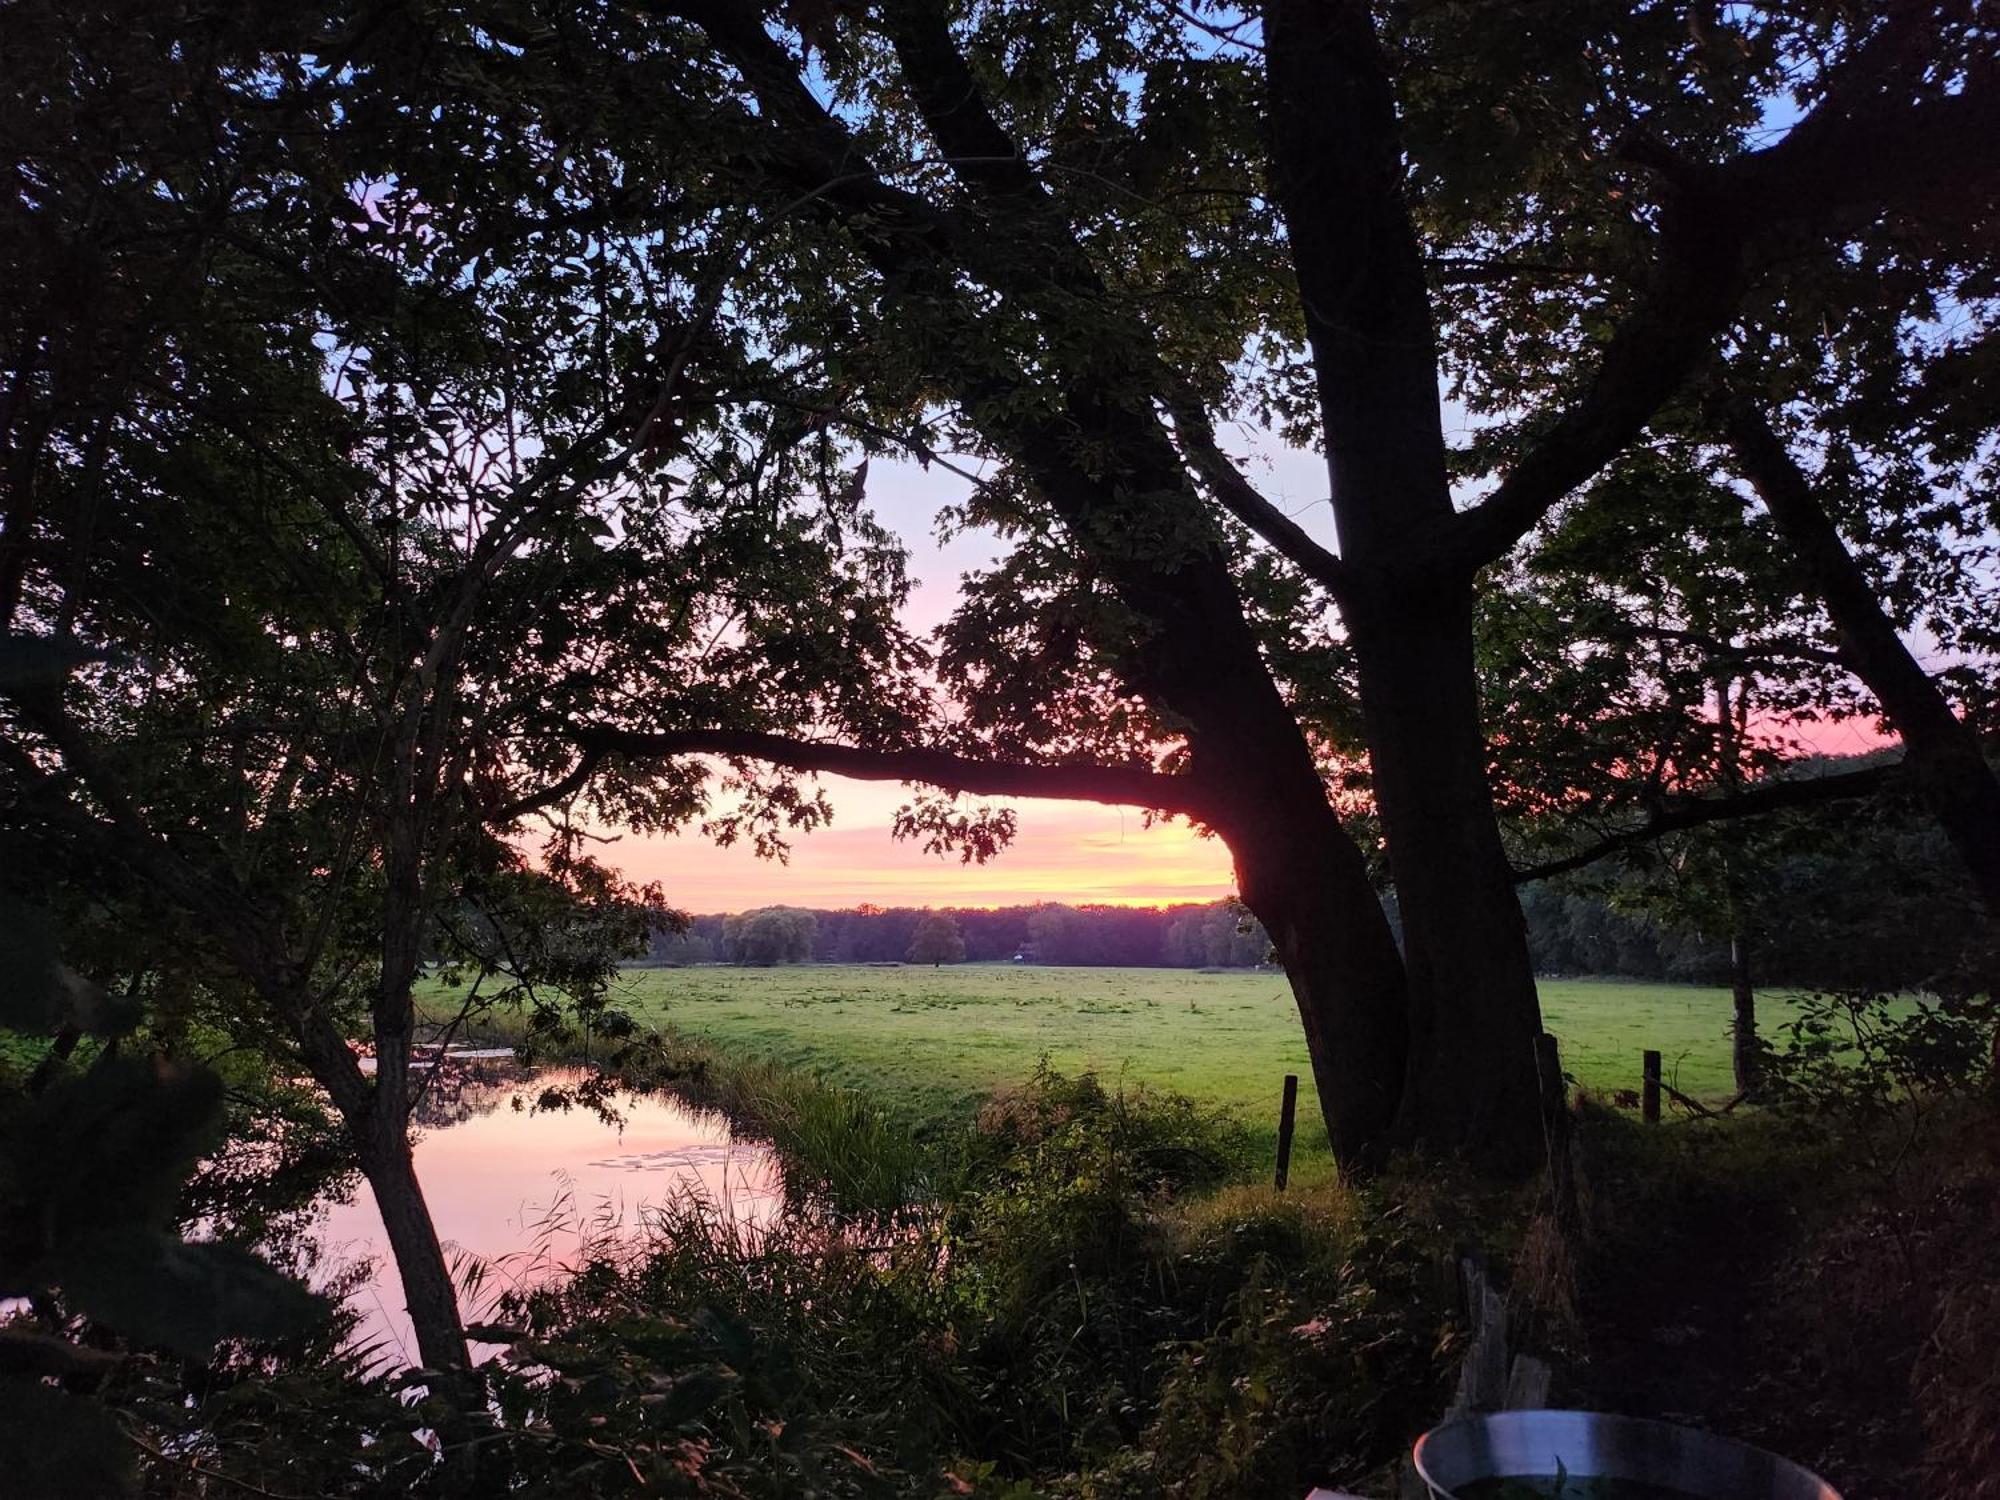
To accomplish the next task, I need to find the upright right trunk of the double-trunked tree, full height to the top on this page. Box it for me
[1264,0,1542,1166]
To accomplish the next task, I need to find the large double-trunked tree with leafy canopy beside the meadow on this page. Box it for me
[504,0,2000,1158]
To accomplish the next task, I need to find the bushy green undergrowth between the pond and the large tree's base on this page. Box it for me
[458,1066,1450,1496]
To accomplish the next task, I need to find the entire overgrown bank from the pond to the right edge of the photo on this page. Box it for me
[145,1000,2000,1500]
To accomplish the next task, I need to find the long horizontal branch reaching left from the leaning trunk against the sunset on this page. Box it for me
[570,724,1220,820]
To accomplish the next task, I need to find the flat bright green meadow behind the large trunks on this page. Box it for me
[584,964,1782,1142]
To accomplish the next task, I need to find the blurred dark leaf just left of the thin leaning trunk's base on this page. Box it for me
[54,1230,326,1358]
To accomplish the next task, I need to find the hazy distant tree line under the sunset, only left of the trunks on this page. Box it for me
[650,902,1270,968]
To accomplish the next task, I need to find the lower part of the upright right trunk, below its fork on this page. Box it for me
[1348,590,1542,1166]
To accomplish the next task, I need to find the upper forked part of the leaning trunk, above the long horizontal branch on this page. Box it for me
[628,0,1312,776]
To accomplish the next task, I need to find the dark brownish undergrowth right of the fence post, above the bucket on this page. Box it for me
[1568,1056,2000,1500]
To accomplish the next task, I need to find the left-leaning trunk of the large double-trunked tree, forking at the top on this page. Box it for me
[656,4,1472,1158]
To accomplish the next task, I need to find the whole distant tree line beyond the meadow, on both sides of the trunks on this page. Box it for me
[650,800,1984,992]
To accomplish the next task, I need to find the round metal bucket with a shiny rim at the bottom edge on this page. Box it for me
[1414,1412,1840,1500]
